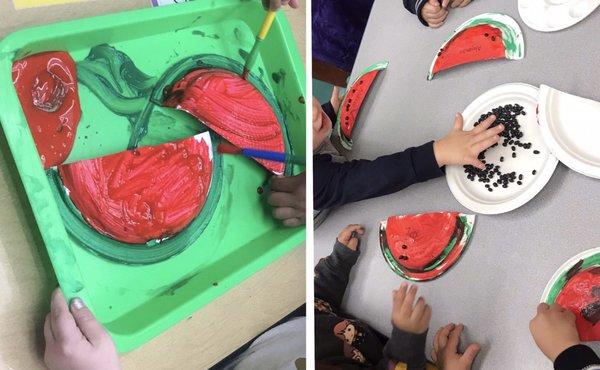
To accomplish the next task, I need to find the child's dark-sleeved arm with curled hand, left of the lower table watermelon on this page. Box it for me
[315,225,365,308]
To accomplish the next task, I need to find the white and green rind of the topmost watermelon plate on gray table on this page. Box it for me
[427,13,525,80]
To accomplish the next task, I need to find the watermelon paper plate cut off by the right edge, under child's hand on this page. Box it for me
[542,248,600,342]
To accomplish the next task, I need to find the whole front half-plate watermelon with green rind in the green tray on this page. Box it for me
[47,131,222,265]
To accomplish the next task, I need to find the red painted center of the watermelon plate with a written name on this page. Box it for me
[433,24,506,74]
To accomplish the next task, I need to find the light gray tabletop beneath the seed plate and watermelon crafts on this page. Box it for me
[315,0,600,370]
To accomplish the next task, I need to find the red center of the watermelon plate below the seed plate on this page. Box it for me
[386,212,461,270]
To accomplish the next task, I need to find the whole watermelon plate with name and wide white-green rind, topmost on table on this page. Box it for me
[427,13,525,80]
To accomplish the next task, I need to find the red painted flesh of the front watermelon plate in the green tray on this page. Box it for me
[59,137,212,244]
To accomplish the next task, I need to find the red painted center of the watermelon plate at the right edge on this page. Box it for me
[556,261,600,342]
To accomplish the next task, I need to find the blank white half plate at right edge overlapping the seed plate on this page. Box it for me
[538,85,600,179]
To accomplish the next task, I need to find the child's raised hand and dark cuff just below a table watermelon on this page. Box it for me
[383,283,431,370]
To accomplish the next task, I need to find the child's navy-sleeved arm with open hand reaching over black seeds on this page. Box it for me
[313,114,504,210]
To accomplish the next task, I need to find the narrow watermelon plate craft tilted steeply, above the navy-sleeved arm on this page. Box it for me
[336,62,388,150]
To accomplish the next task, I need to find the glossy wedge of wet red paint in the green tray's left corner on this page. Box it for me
[12,51,81,168]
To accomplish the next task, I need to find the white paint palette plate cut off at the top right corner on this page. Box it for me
[519,0,600,32]
